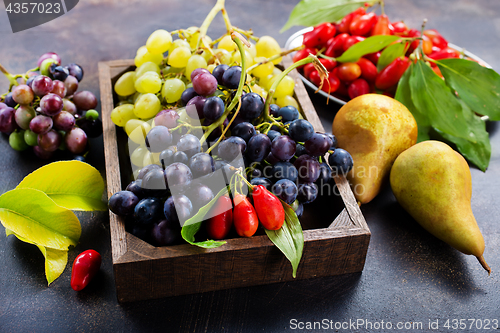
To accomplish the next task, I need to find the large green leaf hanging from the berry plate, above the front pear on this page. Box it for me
[409,60,477,142]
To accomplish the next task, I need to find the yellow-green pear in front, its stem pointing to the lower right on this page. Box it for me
[390,140,491,273]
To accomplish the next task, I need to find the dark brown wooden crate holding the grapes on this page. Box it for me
[99,58,370,302]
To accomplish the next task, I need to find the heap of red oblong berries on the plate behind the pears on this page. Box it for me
[293,7,461,100]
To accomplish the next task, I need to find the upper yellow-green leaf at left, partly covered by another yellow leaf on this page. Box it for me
[16,161,107,211]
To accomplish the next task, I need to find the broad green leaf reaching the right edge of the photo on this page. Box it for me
[436,59,500,120]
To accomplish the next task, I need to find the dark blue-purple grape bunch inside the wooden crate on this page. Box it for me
[109,65,353,246]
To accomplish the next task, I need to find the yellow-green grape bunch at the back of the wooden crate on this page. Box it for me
[111,27,298,137]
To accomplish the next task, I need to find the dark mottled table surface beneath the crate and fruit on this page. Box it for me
[0,0,500,332]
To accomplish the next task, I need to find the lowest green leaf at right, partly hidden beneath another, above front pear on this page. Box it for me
[437,102,491,172]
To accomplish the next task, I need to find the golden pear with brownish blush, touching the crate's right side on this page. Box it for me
[332,94,418,204]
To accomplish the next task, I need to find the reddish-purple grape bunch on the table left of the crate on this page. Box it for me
[0,52,102,159]
